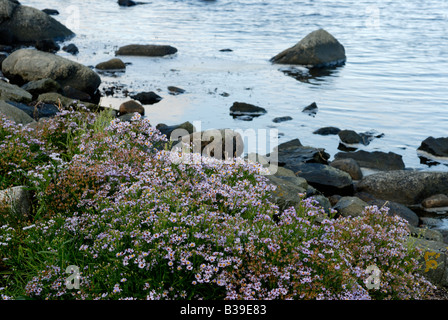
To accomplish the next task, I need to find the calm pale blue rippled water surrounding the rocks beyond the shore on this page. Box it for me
[21,0,448,171]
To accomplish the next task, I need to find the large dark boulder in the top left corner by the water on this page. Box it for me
[0,0,74,44]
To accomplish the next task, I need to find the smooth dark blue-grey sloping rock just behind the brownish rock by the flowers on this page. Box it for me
[285,162,353,196]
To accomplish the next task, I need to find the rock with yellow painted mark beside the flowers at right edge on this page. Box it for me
[409,237,448,287]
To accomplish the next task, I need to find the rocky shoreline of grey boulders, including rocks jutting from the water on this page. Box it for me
[0,0,448,287]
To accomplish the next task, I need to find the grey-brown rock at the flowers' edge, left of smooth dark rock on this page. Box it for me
[266,175,308,210]
